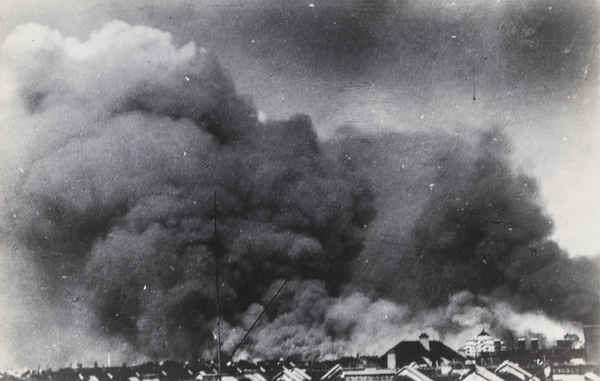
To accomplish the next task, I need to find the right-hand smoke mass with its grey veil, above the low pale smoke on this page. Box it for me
[336,129,599,319]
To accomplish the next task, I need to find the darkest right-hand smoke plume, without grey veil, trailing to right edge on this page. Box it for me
[412,130,598,319]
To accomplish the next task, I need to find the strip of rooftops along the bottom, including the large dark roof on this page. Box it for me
[0,334,600,381]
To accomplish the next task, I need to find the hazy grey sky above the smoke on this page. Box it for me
[0,0,600,255]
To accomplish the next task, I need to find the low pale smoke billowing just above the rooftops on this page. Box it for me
[224,281,579,359]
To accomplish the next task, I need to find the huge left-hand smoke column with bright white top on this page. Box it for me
[4,22,374,359]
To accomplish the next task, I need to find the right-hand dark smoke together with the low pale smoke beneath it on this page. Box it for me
[226,128,600,357]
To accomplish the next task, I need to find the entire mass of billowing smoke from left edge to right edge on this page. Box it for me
[0,14,600,366]
